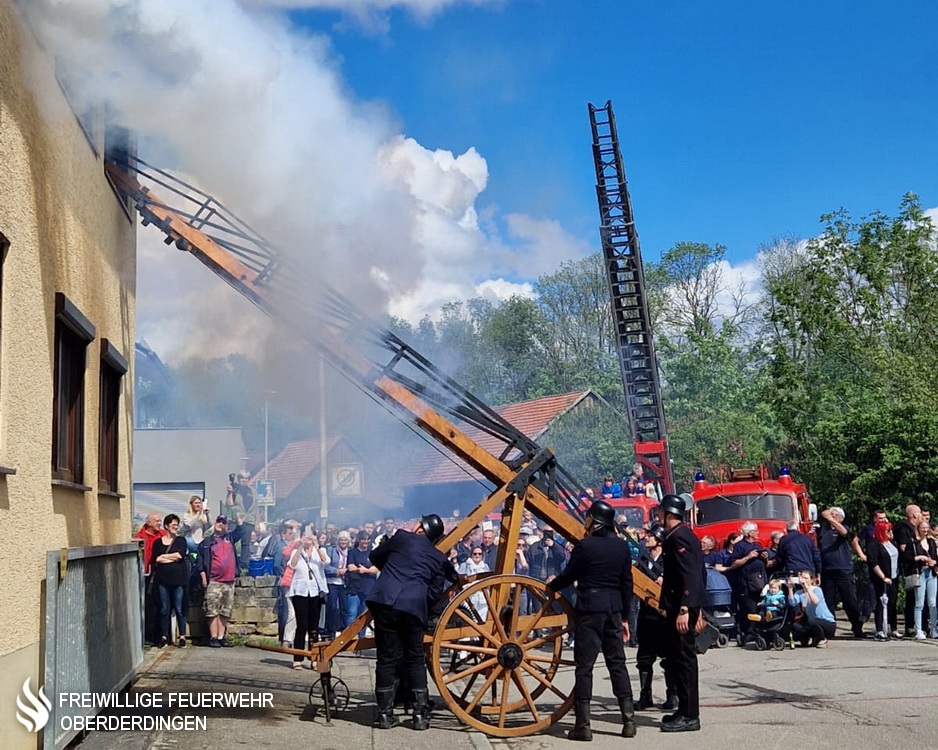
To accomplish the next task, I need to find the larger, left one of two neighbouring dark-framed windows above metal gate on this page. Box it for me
[52,292,94,484]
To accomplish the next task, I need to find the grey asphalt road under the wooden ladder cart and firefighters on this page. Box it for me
[78,628,938,750]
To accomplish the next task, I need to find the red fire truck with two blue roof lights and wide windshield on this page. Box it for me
[690,466,817,545]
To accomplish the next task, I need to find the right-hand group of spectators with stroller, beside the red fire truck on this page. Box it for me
[701,505,938,648]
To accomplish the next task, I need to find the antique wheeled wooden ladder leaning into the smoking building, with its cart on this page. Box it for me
[108,159,659,737]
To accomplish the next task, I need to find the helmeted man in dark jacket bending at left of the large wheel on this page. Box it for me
[367,514,459,729]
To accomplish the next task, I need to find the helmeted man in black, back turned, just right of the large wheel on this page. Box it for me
[548,500,636,741]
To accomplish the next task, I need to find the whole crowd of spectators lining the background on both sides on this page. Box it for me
[136,464,938,649]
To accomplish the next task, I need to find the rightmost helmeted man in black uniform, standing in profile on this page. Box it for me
[658,495,706,732]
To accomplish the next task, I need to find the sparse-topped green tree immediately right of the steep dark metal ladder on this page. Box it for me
[646,242,783,486]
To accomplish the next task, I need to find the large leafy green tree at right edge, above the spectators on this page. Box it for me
[765,194,938,515]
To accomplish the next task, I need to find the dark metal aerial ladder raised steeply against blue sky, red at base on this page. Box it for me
[589,101,674,500]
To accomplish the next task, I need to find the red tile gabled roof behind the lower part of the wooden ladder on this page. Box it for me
[401,390,599,487]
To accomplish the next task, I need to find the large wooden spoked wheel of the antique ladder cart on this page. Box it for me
[429,575,573,737]
